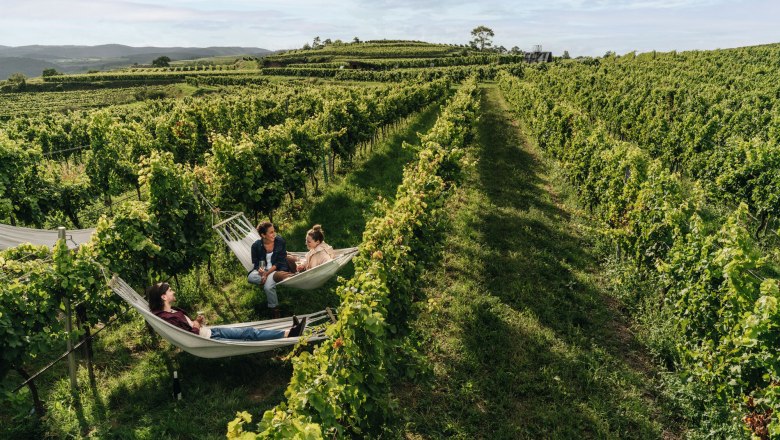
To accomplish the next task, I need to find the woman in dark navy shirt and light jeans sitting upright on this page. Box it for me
[247,222,295,318]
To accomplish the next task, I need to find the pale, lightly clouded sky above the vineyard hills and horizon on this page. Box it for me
[0,0,780,56]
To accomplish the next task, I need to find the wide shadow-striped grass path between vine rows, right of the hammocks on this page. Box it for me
[396,87,672,439]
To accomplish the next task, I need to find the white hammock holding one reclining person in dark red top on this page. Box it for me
[108,275,328,358]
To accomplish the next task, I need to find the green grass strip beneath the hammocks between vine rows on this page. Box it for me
[0,98,450,439]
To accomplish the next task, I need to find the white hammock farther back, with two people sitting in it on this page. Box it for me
[213,212,358,290]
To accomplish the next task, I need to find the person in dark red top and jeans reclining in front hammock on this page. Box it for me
[146,283,306,341]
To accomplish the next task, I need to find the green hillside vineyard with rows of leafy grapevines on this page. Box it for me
[0,40,780,439]
